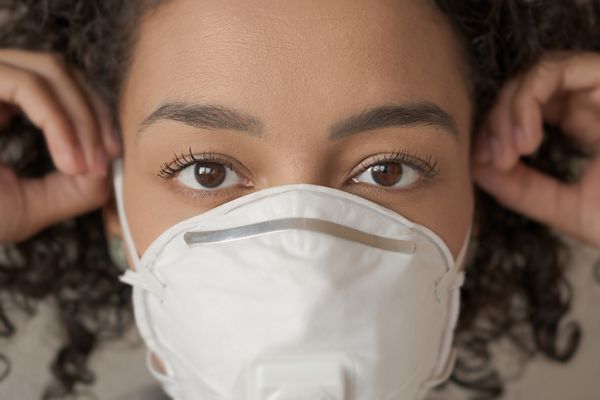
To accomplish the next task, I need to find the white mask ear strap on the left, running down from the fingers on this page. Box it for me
[113,159,165,301]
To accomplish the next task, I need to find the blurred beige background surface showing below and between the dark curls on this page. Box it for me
[0,234,600,400]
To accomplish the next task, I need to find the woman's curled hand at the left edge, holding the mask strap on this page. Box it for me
[0,49,120,244]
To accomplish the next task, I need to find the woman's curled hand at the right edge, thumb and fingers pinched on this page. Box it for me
[474,52,600,246]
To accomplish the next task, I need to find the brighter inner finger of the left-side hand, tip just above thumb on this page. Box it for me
[0,62,86,174]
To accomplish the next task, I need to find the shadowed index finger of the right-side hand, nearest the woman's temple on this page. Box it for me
[476,79,520,171]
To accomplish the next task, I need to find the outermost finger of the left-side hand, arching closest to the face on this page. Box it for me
[0,49,108,176]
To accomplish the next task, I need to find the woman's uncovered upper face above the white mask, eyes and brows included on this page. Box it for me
[119,0,473,256]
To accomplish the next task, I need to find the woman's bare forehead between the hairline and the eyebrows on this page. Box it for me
[123,0,468,138]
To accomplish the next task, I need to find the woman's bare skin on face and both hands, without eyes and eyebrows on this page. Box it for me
[0,0,600,386]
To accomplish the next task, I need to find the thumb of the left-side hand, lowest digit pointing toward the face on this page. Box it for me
[15,171,110,240]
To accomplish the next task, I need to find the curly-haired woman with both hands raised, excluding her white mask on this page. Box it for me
[0,0,600,396]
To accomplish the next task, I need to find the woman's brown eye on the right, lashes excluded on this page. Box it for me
[352,162,420,188]
